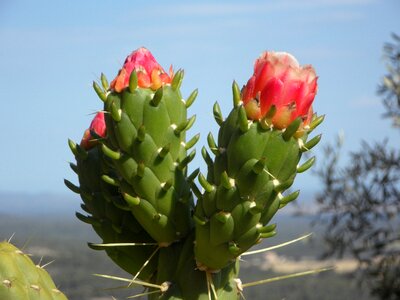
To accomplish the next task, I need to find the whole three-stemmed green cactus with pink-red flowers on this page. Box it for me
[65,48,323,299]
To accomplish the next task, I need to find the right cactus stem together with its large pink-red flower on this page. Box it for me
[195,52,317,270]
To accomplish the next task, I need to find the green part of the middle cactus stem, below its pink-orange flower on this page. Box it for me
[103,71,198,246]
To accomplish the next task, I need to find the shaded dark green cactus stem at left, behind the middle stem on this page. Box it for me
[65,141,157,279]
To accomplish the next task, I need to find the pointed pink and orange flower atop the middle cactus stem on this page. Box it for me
[110,47,173,93]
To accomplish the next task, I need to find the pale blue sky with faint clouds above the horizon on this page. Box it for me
[0,0,400,194]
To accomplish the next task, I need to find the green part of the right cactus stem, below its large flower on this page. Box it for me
[194,83,320,270]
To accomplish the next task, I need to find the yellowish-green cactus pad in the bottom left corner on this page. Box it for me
[0,241,67,300]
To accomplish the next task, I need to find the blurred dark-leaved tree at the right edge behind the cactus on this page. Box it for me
[316,34,400,300]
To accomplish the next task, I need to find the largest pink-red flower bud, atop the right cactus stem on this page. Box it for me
[242,51,317,129]
